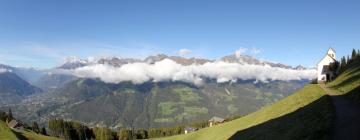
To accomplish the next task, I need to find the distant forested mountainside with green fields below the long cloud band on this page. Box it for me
[14,79,307,128]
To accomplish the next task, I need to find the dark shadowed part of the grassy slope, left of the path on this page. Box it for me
[230,91,335,140]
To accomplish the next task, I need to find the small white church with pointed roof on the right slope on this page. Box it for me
[317,48,336,83]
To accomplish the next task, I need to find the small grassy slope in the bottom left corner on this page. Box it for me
[0,121,59,140]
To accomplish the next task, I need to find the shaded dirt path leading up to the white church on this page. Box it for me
[320,84,360,140]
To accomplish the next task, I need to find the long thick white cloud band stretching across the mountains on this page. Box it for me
[66,59,316,84]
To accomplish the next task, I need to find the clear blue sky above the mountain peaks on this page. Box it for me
[0,0,360,68]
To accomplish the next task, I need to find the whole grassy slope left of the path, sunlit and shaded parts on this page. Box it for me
[164,85,334,140]
